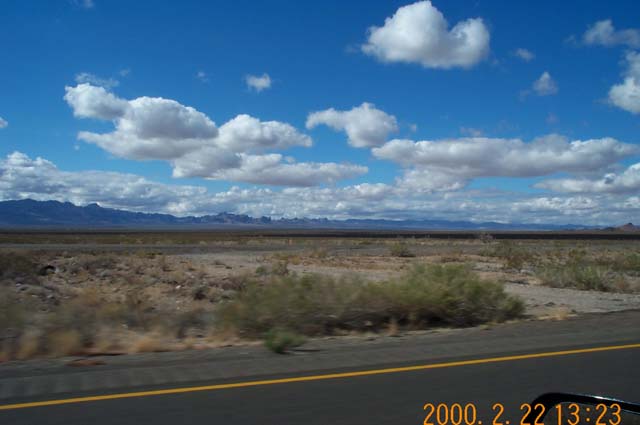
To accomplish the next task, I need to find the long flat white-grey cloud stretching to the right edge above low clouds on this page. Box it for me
[373,135,639,190]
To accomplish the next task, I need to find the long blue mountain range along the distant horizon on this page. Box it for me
[0,199,608,230]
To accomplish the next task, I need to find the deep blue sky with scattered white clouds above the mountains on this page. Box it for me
[0,0,640,225]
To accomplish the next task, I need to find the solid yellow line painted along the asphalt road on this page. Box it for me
[0,344,640,410]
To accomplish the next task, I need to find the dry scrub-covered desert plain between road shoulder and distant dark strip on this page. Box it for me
[0,235,640,361]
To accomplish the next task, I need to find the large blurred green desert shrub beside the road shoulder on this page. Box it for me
[217,265,523,337]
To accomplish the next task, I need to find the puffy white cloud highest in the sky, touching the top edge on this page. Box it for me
[362,1,490,69]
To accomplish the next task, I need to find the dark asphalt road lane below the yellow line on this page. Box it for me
[0,342,640,425]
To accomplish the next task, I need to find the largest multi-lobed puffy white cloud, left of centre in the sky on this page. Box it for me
[65,83,367,186]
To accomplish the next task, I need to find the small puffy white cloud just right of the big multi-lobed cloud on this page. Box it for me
[306,102,398,148]
